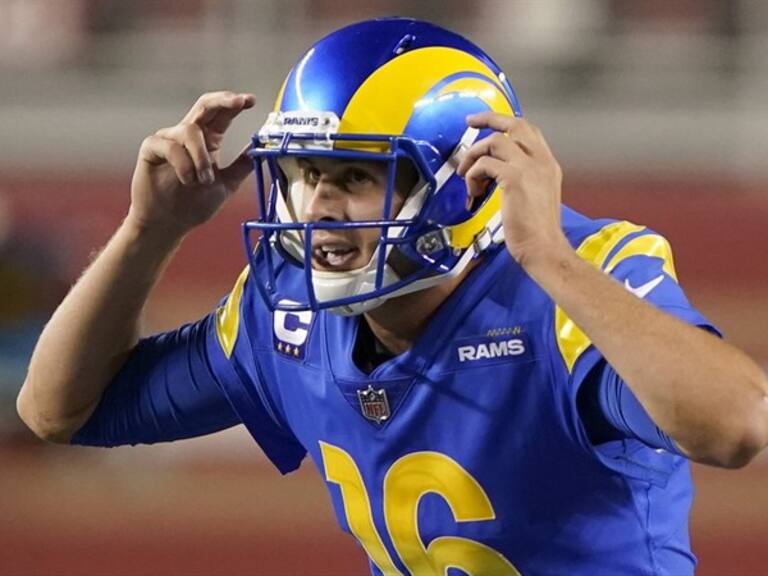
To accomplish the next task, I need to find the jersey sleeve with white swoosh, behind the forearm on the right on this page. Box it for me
[555,222,720,484]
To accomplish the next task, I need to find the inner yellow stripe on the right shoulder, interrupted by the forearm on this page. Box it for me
[555,222,643,372]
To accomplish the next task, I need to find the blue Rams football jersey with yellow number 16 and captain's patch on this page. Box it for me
[76,208,714,575]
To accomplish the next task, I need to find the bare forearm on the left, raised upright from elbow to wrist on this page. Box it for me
[17,217,180,441]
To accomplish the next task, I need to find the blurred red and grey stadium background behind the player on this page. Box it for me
[0,0,768,575]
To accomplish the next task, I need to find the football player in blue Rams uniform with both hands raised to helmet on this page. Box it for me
[18,18,768,575]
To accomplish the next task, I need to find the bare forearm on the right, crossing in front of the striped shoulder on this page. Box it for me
[526,242,768,466]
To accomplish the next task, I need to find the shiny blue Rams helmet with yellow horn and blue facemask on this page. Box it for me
[243,18,521,315]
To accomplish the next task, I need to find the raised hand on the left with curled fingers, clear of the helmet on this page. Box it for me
[128,92,255,236]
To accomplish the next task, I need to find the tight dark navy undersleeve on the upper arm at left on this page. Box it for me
[71,316,240,446]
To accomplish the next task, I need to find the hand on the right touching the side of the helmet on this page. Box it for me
[457,112,568,268]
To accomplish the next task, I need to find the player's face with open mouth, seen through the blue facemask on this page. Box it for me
[299,158,416,271]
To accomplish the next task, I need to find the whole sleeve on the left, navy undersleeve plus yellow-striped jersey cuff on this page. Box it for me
[71,268,306,474]
